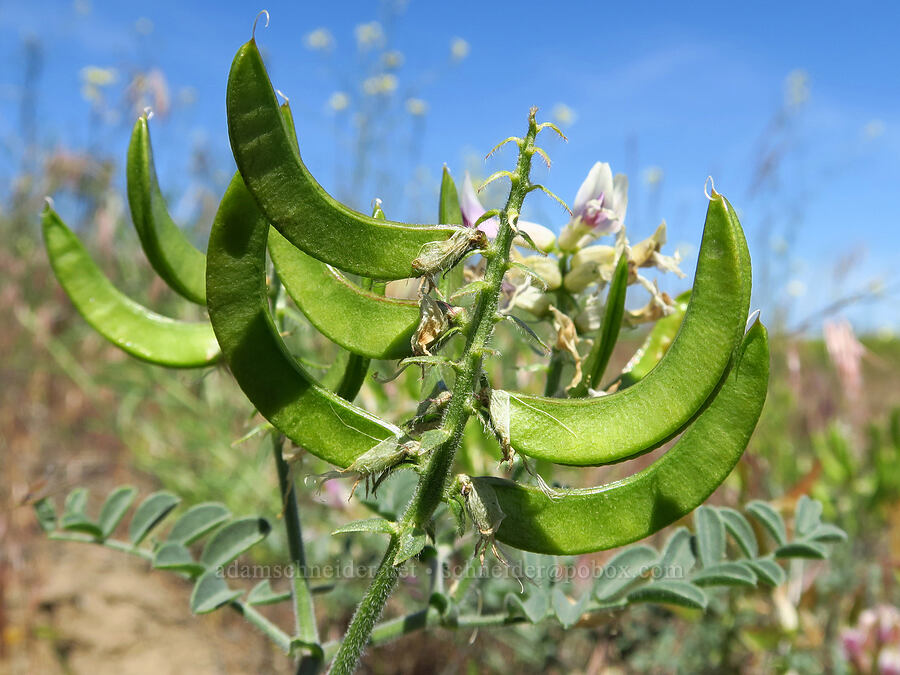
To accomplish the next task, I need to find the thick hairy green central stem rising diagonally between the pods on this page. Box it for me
[329,109,538,675]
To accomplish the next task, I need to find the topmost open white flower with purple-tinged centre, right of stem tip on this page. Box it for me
[559,162,628,251]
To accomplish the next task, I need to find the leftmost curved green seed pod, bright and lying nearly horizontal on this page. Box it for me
[41,205,220,368]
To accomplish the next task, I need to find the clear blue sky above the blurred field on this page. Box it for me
[0,0,900,330]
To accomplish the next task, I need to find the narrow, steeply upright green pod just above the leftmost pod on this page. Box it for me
[127,115,206,305]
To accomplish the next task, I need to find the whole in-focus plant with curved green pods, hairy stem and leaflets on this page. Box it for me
[37,18,844,673]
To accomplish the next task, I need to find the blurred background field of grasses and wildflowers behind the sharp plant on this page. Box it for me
[0,3,900,673]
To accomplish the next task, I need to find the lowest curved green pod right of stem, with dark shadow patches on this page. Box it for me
[473,322,769,555]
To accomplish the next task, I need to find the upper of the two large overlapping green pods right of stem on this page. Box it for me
[500,194,750,466]
